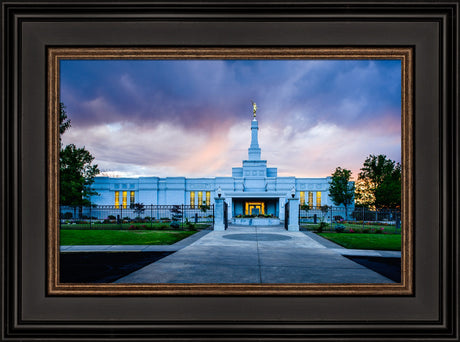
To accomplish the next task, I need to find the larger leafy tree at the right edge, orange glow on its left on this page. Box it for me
[358,154,401,208]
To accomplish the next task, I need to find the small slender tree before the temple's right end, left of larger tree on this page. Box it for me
[329,166,355,217]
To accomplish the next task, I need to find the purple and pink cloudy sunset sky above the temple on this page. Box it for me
[60,60,401,178]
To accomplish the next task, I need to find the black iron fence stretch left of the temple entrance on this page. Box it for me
[60,205,214,229]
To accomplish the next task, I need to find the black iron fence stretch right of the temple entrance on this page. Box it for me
[299,206,401,233]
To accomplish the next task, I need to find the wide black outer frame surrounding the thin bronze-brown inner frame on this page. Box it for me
[1,1,460,341]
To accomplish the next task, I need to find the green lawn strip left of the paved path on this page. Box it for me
[60,230,196,246]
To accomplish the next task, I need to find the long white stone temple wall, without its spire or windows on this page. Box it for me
[92,176,351,215]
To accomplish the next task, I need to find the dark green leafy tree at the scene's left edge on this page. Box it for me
[59,103,99,216]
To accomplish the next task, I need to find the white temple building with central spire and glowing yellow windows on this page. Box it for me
[91,112,333,220]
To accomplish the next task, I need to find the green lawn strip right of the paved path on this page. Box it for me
[318,233,401,251]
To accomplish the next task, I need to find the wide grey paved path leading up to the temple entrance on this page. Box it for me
[116,226,393,284]
